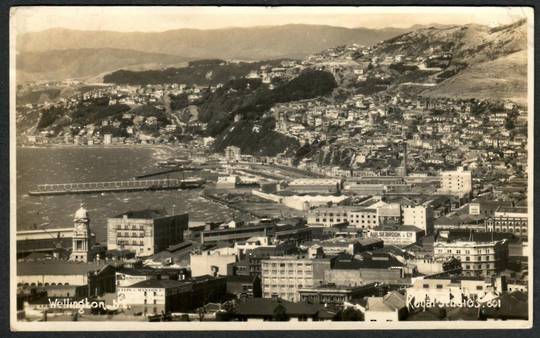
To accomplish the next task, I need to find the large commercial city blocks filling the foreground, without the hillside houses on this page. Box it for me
[17,165,528,321]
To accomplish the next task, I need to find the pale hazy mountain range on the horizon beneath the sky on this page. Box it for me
[16,25,410,83]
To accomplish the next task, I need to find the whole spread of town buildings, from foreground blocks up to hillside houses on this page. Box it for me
[17,41,532,322]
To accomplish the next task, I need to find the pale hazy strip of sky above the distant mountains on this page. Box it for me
[11,6,526,33]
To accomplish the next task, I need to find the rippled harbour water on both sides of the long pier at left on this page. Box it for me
[16,146,245,242]
